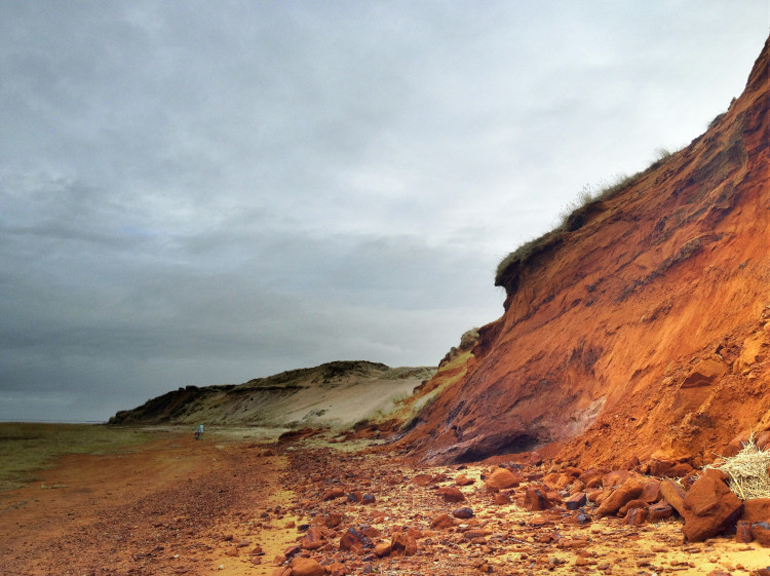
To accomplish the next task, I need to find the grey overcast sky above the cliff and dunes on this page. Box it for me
[0,0,770,420]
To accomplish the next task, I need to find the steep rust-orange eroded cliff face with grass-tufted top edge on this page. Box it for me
[404,35,770,465]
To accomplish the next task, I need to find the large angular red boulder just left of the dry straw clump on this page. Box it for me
[682,468,743,542]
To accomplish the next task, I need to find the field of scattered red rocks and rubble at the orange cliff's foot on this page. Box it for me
[264,449,770,576]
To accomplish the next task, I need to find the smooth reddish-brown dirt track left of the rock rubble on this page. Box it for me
[0,436,296,576]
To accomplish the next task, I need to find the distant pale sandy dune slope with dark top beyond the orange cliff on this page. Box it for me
[110,361,435,428]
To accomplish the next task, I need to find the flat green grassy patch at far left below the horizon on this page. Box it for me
[0,422,157,491]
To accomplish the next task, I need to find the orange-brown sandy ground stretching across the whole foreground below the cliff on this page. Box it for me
[0,435,770,576]
